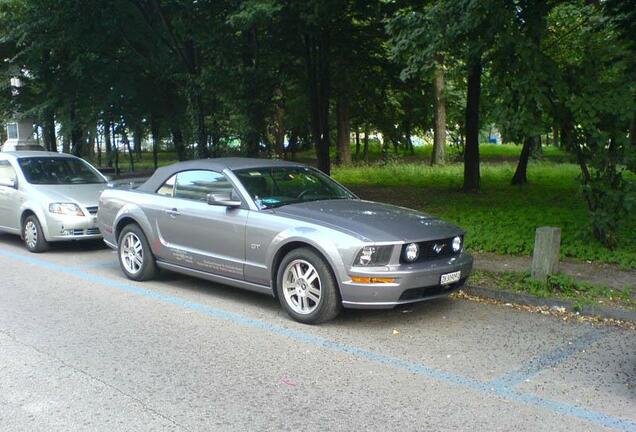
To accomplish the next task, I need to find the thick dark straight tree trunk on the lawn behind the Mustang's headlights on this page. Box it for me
[464,57,481,192]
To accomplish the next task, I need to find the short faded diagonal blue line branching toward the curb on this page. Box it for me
[490,330,609,388]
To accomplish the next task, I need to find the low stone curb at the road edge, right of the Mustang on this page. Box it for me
[462,285,636,322]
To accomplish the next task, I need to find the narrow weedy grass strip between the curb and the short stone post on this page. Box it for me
[471,271,636,309]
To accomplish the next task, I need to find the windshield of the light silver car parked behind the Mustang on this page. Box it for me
[18,157,105,185]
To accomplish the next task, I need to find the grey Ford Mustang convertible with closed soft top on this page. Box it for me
[98,158,473,323]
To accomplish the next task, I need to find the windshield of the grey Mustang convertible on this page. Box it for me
[234,167,355,209]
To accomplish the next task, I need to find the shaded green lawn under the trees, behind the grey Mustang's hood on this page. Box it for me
[333,162,636,268]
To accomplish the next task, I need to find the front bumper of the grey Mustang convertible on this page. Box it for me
[340,253,473,309]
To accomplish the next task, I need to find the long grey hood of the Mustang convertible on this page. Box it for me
[274,200,463,242]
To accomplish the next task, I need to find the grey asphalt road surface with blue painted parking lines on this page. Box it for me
[0,235,636,432]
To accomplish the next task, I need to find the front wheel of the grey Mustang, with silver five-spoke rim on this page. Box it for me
[276,248,342,324]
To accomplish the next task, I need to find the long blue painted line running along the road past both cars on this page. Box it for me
[0,246,636,432]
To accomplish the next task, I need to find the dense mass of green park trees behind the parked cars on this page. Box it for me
[0,0,636,245]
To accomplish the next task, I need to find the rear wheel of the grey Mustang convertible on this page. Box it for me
[117,224,157,282]
